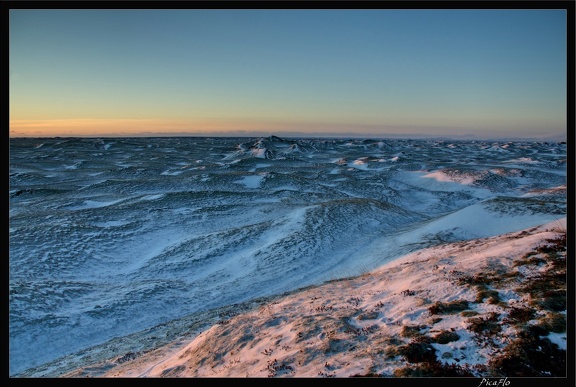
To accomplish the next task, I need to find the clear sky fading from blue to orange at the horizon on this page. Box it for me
[9,9,567,138]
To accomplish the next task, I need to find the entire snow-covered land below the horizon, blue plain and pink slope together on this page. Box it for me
[9,136,567,377]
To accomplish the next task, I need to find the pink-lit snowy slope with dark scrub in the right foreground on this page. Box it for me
[61,219,573,382]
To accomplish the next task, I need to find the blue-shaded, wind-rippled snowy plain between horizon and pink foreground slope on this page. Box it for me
[9,136,566,375]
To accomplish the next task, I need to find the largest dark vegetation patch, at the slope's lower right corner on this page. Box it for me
[385,230,567,377]
